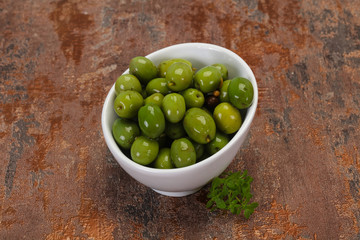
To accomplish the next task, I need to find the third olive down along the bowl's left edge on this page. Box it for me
[114,90,144,118]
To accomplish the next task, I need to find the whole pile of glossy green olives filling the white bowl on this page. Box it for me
[112,56,254,169]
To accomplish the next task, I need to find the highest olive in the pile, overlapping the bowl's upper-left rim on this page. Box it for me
[129,56,158,85]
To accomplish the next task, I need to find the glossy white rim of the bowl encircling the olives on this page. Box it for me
[101,42,258,175]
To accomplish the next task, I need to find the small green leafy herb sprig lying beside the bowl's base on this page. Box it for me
[206,170,259,219]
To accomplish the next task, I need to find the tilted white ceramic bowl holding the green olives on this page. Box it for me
[101,43,258,197]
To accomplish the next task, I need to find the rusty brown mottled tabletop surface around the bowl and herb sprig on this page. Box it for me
[0,0,360,240]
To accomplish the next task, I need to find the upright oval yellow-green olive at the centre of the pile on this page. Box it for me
[161,93,186,123]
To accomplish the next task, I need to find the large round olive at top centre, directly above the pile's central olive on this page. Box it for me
[165,62,193,92]
